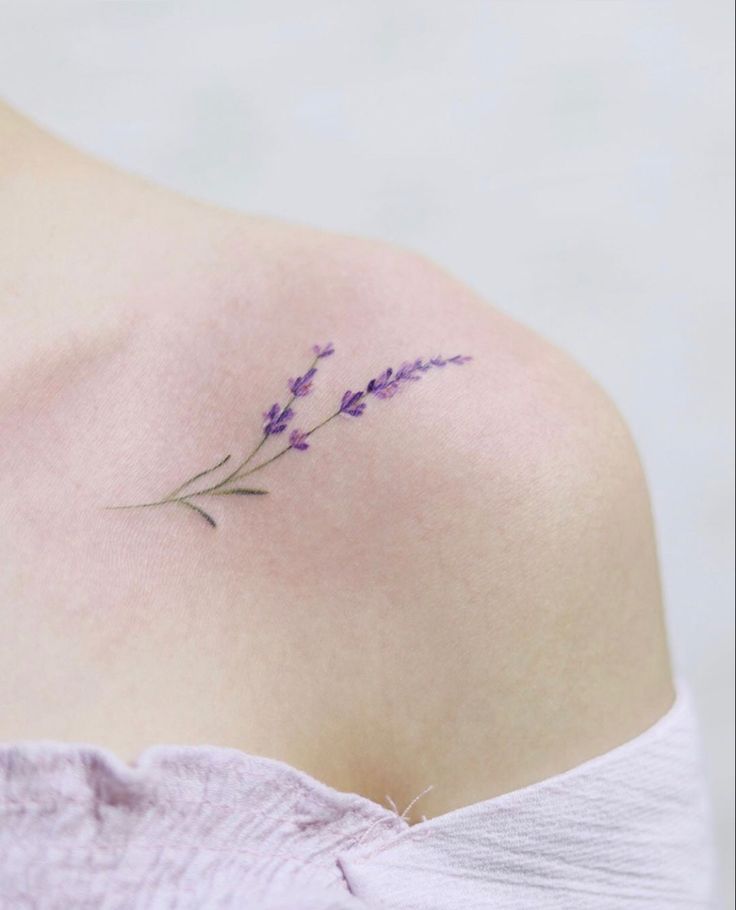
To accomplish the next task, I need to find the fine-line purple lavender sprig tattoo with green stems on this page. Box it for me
[107,342,472,528]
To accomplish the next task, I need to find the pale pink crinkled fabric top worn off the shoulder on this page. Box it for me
[0,685,715,910]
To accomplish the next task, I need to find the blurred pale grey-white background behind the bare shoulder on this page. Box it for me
[0,0,734,906]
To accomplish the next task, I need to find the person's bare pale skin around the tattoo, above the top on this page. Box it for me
[0,103,673,820]
